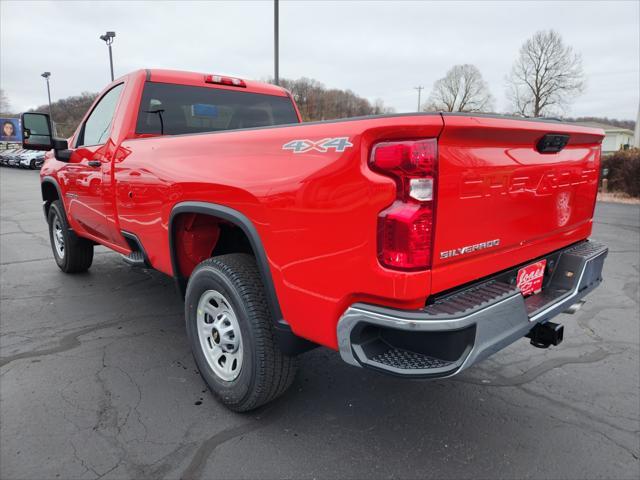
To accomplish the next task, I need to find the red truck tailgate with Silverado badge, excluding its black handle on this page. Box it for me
[432,114,603,293]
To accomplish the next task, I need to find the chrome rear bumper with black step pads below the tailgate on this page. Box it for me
[337,241,608,378]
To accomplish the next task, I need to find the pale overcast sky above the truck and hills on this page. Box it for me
[0,0,640,119]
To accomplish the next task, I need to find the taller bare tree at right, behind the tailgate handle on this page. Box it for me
[507,30,584,117]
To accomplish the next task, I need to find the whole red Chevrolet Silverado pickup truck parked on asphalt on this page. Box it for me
[22,70,607,411]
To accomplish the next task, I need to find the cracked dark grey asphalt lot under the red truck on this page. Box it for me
[0,168,640,479]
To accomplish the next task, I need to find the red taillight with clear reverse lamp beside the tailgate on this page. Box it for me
[370,138,438,270]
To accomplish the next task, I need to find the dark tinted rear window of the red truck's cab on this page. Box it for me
[136,82,298,135]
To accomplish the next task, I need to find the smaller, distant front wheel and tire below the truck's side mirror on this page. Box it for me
[47,200,93,273]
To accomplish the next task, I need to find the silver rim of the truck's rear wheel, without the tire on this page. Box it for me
[197,290,242,382]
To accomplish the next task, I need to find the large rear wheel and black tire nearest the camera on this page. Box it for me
[185,254,297,412]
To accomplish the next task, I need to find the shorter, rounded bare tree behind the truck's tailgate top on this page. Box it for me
[425,64,493,112]
